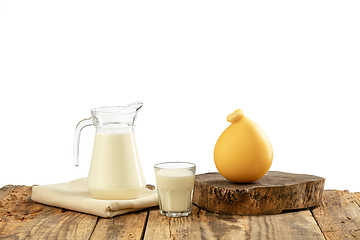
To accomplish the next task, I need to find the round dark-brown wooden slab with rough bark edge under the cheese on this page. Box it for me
[193,171,325,215]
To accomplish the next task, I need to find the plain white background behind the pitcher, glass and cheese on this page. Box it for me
[0,0,360,191]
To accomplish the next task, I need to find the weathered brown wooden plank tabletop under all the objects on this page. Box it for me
[0,185,360,240]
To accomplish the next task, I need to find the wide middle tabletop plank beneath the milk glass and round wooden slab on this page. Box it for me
[144,205,325,240]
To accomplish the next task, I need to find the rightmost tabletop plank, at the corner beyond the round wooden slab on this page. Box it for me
[311,190,360,239]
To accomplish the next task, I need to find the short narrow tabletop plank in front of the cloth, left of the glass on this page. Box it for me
[91,209,148,240]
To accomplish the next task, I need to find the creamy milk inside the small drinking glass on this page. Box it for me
[155,169,195,212]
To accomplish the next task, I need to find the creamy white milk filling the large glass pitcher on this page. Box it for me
[87,131,145,199]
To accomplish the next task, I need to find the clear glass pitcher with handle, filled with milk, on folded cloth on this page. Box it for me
[74,102,145,200]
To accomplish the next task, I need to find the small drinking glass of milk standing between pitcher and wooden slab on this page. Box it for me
[154,162,196,217]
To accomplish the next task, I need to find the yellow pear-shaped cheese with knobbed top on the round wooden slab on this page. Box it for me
[214,109,273,183]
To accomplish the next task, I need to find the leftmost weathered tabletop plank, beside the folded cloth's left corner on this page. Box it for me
[0,186,97,239]
